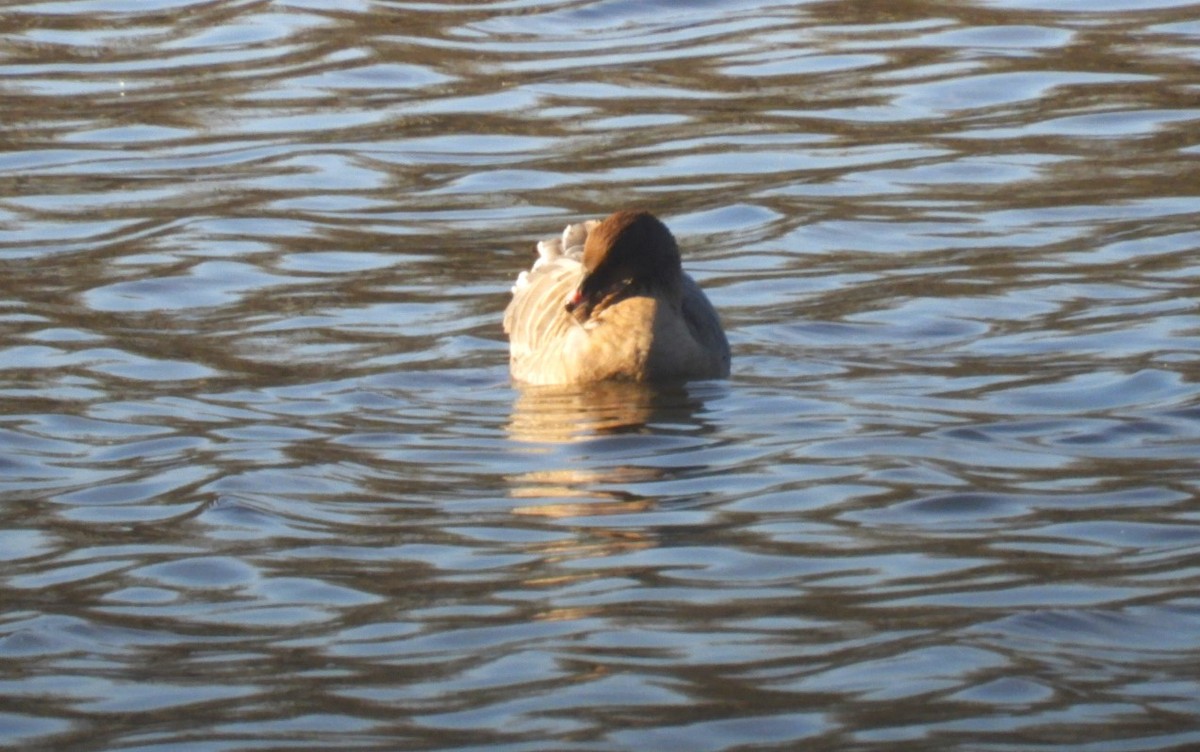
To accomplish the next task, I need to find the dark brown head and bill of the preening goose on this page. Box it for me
[566,210,683,323]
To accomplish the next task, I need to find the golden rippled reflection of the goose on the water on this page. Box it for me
[506,383,721,620]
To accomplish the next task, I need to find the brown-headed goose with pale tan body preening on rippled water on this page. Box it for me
[504,209,730,385]
